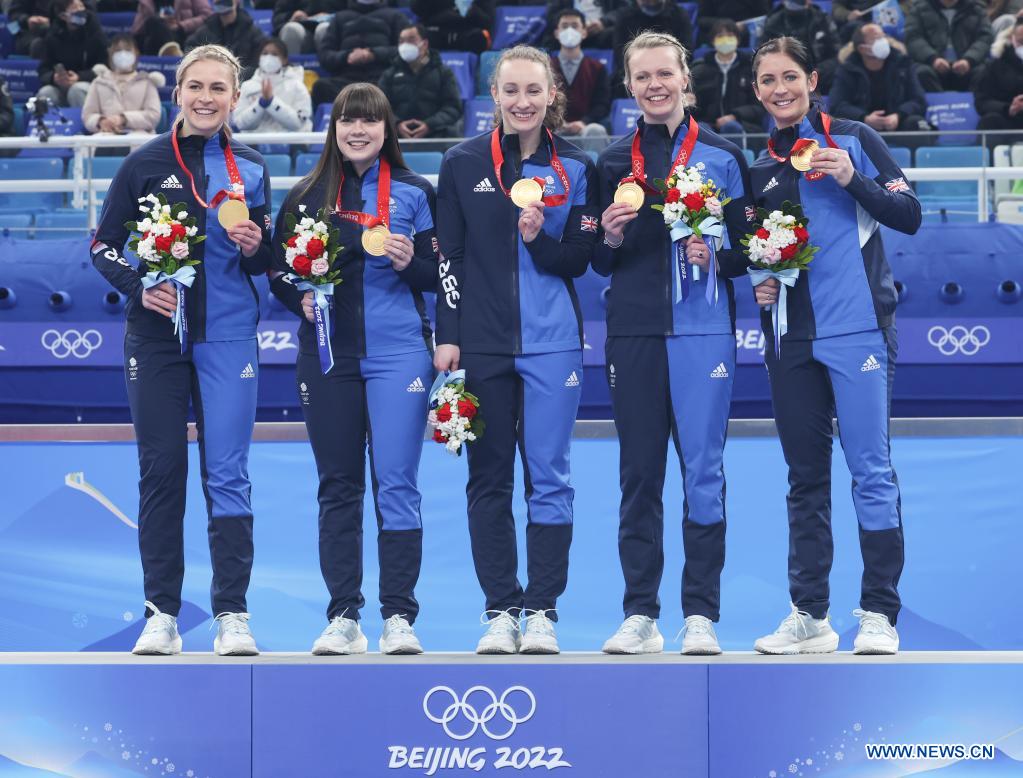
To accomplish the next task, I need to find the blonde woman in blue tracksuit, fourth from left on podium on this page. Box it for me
[593,33,752,654]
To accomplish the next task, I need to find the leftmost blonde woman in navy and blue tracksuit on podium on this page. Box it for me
[91,46,271,654]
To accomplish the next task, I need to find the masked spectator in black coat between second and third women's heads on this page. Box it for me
[380,25,461,138]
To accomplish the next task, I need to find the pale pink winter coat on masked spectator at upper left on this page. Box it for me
[82,65,165,133]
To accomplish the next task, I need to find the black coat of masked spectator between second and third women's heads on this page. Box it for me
[380,51,461,138]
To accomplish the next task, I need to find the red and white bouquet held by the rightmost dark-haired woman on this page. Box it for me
[742,200,818,355]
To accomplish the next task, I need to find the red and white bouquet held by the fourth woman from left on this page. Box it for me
[651,163,731,305]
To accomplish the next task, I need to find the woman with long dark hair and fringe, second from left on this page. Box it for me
[271,84,437,654]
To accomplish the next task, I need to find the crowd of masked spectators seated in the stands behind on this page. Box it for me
[0,0,1023,144]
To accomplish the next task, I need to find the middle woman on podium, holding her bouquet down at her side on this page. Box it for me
[434,40,598,653]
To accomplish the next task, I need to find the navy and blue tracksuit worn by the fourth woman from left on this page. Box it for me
[593,117,752,621]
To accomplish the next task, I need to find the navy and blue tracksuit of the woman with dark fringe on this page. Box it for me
[271,162,437,623]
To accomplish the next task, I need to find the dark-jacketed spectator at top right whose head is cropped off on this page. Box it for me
[905,0,994,92]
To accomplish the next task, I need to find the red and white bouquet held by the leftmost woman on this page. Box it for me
[125,193,206,354]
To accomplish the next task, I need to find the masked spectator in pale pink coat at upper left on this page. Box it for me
[82,35,165,134]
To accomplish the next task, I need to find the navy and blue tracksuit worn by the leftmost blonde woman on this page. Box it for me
[91,127,271,615]
